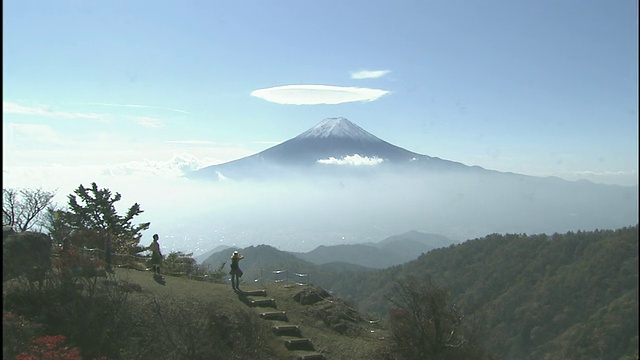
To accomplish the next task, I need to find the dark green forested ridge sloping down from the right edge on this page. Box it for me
[322,225,638,359]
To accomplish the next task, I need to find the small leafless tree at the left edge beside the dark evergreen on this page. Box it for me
[2,188,56,232]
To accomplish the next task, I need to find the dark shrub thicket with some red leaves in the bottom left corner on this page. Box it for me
[3,240,278,360]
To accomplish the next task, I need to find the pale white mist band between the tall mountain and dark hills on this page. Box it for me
[37,169,638,256]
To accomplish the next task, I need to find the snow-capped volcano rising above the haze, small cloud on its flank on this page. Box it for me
[189,117,478,180]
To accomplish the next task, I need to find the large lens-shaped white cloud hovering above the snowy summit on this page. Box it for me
[251,85,389,105]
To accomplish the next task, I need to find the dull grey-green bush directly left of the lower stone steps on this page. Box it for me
[127,297,276,360]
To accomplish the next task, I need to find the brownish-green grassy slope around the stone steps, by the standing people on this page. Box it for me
[115,269,387,360]
